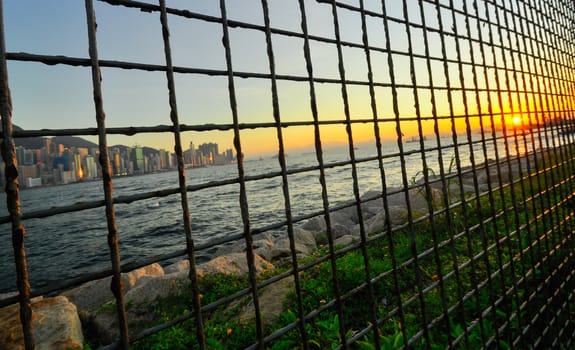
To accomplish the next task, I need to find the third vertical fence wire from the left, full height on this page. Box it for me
[156,0,206,349]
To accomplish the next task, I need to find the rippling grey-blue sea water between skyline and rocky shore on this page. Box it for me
[0,129,562,293]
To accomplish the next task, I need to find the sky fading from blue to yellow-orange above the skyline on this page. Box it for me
[4,0,540,154]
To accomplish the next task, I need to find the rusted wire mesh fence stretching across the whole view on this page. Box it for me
[0,0,575,349]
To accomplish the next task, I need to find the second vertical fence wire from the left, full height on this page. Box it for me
[85,0,130,349]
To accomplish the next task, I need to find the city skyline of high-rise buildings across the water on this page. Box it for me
[0,138,234,190]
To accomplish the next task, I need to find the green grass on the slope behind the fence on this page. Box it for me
[91,148,575,349]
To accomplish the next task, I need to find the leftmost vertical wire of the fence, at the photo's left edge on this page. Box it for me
[0,0,35,350]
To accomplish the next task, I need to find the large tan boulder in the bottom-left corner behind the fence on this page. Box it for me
[0,296,84,350]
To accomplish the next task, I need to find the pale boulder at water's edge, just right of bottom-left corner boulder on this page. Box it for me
[61,263,164,312]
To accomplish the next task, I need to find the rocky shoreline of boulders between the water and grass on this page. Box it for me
[0,155,534,349]
